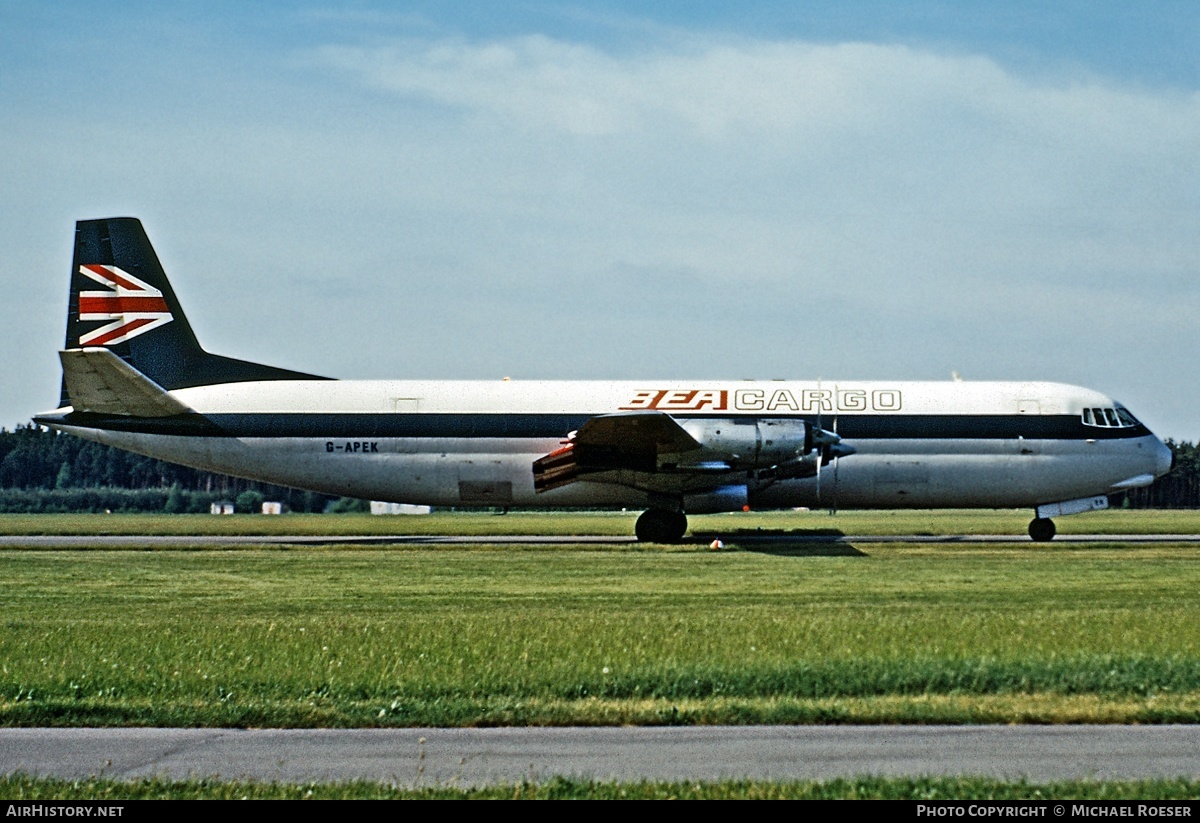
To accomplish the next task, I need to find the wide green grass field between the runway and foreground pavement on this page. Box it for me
[0,542,1200,727]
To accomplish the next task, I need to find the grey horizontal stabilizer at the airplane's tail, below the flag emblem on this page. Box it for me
[59,348,192,417]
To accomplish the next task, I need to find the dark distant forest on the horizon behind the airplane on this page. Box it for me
[0,423,1200,512]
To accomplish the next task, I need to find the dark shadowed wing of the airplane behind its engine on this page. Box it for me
[533,412,705,492]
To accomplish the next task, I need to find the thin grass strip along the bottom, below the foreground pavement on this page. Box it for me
[0,775,1200,800]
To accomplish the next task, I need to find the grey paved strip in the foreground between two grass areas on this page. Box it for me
[0,726,1200,787]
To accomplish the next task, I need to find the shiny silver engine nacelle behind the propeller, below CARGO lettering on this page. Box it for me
[677,417,814,469]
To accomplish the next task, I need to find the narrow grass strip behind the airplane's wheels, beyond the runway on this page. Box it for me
[0,509,1200,537]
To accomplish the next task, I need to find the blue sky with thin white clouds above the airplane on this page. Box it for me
[0,0,1200,440]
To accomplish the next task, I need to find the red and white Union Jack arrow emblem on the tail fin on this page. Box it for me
[79,265,174,346]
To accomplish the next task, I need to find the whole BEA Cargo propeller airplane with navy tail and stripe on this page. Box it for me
[35,217,1171,542]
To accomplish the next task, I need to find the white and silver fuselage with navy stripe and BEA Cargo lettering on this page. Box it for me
[52,380,1170,512]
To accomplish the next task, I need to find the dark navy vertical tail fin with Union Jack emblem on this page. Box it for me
[59,217,328,406]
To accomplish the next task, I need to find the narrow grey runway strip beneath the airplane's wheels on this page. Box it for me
[0,533,1200,549]
